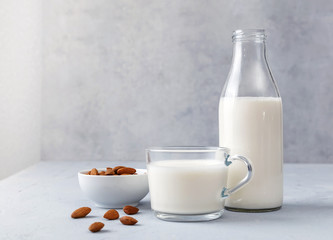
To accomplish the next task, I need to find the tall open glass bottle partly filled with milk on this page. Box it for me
[219,29,283,212]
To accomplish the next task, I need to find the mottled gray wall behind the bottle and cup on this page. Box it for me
[42,0,333,163]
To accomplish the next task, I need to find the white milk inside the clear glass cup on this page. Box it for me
[147,159,228,214]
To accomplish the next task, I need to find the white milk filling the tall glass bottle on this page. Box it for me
[219,97,283,209]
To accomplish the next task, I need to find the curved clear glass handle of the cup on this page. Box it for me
[221,155,253,198]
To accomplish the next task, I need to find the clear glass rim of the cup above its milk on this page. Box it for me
[146,146,230,153]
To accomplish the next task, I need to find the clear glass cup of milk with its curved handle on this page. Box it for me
[146,147,253,222]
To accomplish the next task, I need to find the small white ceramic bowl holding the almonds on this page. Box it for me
[78,168,149,208]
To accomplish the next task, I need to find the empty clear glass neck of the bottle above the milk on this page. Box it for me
[222,38,279,97]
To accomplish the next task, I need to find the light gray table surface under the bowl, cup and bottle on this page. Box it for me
[0,162,333,240]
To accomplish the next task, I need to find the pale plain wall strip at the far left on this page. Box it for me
[0,0,42,180]
